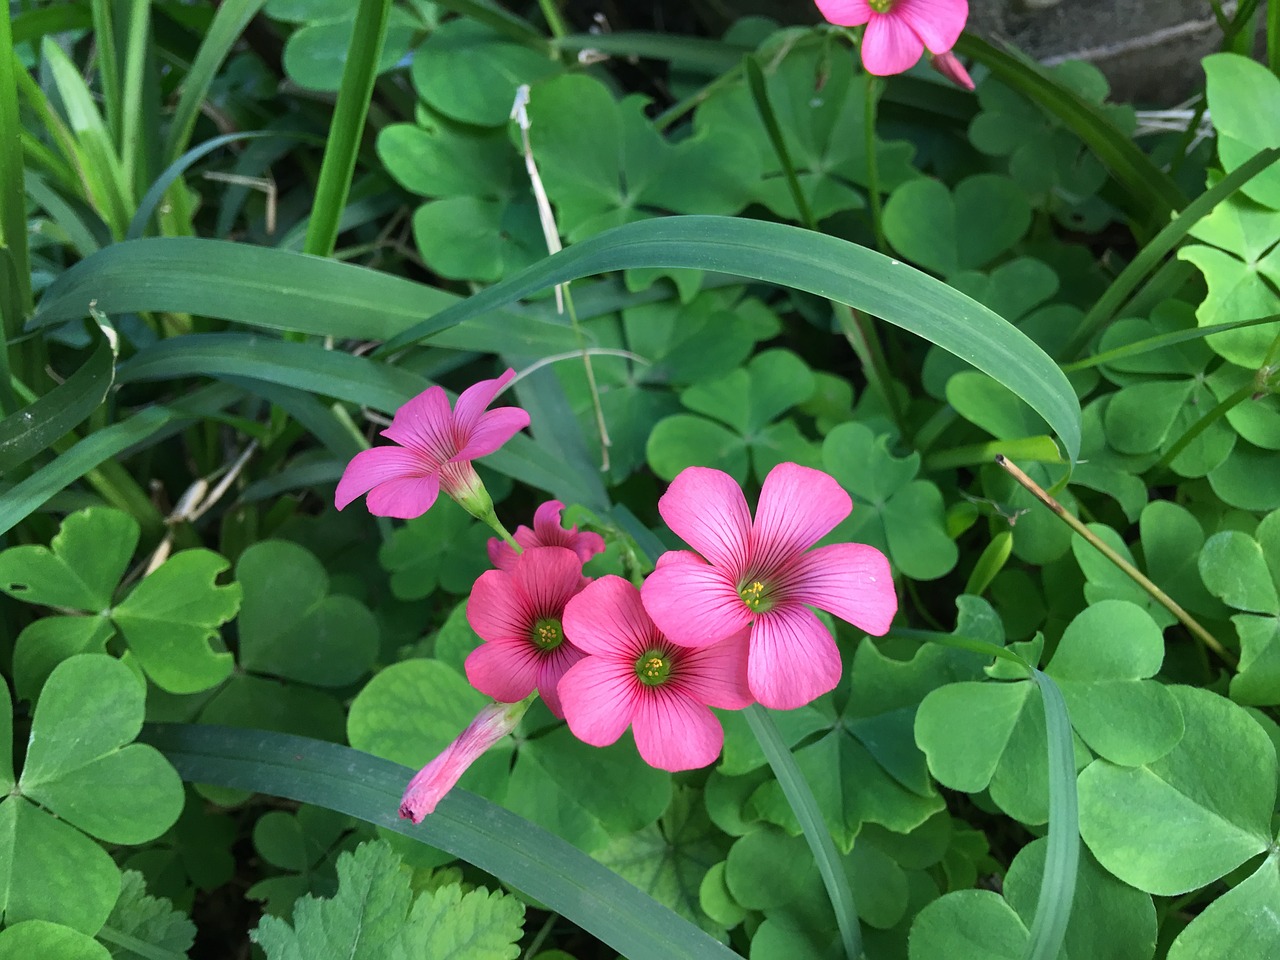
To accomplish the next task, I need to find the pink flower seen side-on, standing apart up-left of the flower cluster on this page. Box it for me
[333,370,529,520]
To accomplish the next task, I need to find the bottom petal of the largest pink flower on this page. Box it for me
[746,604,841,710]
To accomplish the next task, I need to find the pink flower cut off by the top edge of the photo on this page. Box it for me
[818,0,969,77]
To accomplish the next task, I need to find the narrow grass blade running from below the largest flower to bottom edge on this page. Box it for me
[742,704,863,960]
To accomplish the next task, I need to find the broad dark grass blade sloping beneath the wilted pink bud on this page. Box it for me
[141,724,741,960]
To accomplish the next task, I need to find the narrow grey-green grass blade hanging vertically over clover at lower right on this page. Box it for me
[1027,669,1080,960]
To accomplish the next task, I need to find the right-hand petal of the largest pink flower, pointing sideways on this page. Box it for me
[787,543,897,636]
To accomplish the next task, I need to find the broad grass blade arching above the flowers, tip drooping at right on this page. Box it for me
[375,216,1080,461]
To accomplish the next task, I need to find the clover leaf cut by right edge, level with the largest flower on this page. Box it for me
[1198,511,1280,705]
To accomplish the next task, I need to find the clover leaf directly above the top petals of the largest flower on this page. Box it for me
[645,349,818,483]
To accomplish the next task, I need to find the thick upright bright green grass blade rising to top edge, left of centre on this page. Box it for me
[303,0,392,257]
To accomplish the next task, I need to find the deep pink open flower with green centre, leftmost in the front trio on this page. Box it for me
[466,547,588,717]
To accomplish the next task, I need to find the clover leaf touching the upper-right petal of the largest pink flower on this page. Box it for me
[822,422,959,580]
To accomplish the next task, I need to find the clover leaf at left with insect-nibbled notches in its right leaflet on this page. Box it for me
[0,507,241,698]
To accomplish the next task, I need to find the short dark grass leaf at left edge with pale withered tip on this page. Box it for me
[0,323,116,474]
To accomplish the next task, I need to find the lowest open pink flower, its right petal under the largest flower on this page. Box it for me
[559,576,751,771]
